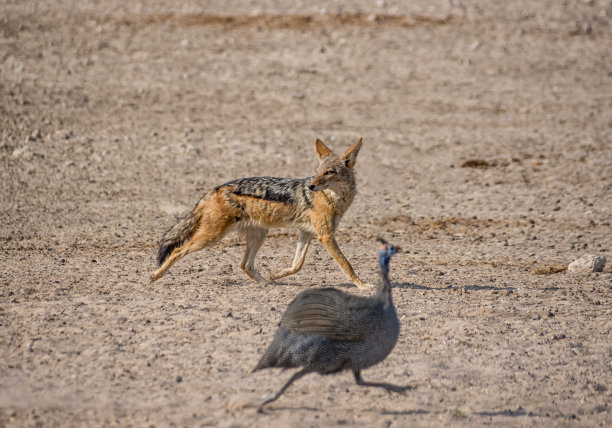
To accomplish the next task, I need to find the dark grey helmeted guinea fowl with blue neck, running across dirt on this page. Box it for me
[253,238,410,412]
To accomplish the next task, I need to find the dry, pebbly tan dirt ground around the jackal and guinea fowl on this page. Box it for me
[0,0,612,427]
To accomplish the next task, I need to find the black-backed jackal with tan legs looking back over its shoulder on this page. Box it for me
[151,138,366,288]
